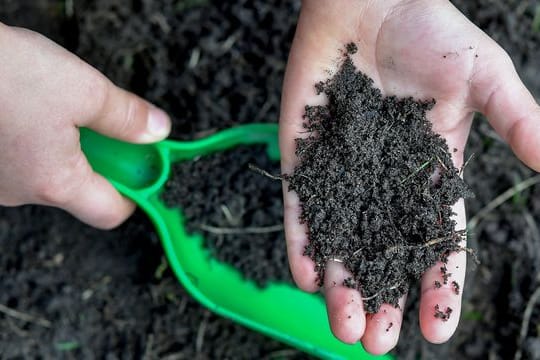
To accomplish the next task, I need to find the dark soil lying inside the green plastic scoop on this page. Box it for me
[163,145,291,286]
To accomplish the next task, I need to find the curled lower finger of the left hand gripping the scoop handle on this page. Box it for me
[41,153,135,229]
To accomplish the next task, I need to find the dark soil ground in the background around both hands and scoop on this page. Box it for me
[0,0,540,360]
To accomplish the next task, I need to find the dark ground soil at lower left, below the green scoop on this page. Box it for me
[0,206,306,359]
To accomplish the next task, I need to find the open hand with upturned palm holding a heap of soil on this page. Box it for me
[280,0,540,354]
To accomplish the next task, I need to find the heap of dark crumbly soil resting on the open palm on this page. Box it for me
[286,44,470,313]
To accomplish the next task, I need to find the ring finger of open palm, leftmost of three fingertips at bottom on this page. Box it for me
[324,261,366,344]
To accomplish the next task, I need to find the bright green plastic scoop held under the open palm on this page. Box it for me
[81,124,391,359]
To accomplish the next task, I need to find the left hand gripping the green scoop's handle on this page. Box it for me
[0,24,170,228]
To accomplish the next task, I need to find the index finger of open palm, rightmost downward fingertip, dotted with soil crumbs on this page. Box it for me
[419,199,467,344]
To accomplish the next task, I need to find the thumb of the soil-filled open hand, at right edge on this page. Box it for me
[471,48,540,171]
